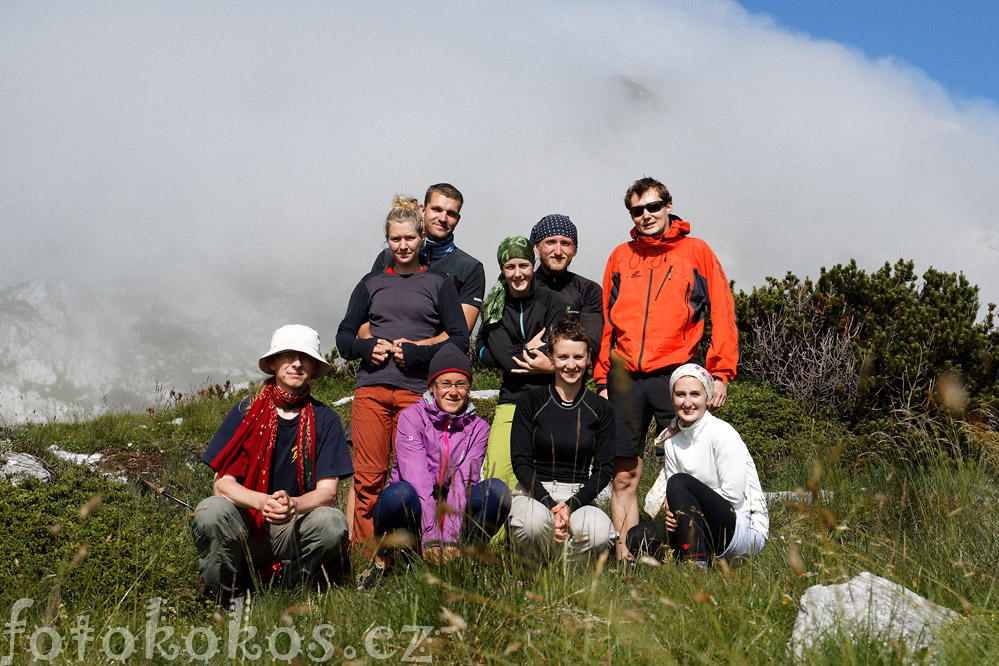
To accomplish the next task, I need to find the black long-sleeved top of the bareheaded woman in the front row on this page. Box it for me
[510,386,614,511]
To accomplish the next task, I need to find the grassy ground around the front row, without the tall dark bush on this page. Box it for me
[0,376,999,664]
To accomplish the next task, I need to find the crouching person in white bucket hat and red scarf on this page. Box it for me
[191,324,354,605]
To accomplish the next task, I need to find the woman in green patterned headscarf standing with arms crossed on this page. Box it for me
[475,236,565,488]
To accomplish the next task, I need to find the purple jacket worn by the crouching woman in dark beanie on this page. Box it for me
[390,392,489,548]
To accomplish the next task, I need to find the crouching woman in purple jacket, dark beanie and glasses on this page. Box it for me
[358,344,510,589]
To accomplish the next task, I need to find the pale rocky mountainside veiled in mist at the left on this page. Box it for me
[0,280,259,423]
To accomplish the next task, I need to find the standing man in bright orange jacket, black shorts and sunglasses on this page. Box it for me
[593,178,739,559]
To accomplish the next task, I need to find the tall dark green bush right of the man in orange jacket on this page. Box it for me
[736,255,999,431]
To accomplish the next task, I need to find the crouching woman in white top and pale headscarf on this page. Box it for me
[627,363,770,566]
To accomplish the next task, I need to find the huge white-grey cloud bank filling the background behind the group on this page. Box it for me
[0,0,999,416]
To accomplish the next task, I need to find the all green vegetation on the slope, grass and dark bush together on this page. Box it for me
[0,261,999,665]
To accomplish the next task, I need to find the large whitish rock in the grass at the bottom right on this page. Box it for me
[788,571,961,663]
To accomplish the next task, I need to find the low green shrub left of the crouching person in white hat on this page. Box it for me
[0,466,198,608]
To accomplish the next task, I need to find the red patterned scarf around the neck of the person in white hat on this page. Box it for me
[210,379,316,541]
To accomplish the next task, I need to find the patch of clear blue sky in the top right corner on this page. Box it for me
[739,0,999,101]
